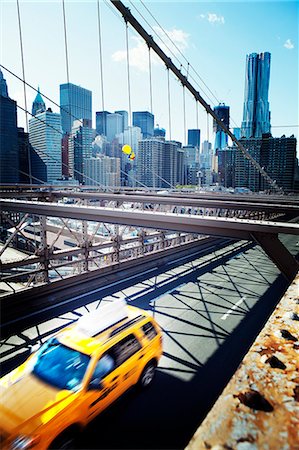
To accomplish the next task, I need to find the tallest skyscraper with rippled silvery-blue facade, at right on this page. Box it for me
[241,52,271,138]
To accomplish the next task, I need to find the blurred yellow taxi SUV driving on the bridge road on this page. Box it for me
[0,299,162,450]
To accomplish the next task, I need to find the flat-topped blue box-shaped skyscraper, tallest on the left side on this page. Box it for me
[60,83,92,134]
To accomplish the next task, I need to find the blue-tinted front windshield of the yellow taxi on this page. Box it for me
[32,338,90,391]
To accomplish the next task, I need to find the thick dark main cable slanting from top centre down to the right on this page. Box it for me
[110,0,283,193]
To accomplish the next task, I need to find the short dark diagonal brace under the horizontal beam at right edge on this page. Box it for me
[252,232,299,283]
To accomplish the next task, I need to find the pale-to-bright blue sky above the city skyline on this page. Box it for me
[0,0,299,148]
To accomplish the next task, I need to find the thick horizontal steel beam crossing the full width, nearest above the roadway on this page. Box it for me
[0,200,299,240]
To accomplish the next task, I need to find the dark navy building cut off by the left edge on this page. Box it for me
[0,70,19,183]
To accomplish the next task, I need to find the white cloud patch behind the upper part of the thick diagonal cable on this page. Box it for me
[112,27,189,72]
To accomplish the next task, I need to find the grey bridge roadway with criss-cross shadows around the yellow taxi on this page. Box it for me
[2,235,299,449]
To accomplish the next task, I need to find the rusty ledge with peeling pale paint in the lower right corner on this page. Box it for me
[186,274,299,450]
